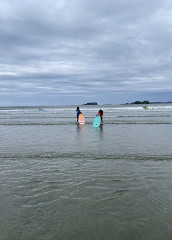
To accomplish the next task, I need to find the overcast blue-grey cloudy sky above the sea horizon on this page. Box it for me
[0,0,172,105]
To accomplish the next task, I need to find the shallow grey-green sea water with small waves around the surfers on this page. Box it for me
[0,104,172,240]
